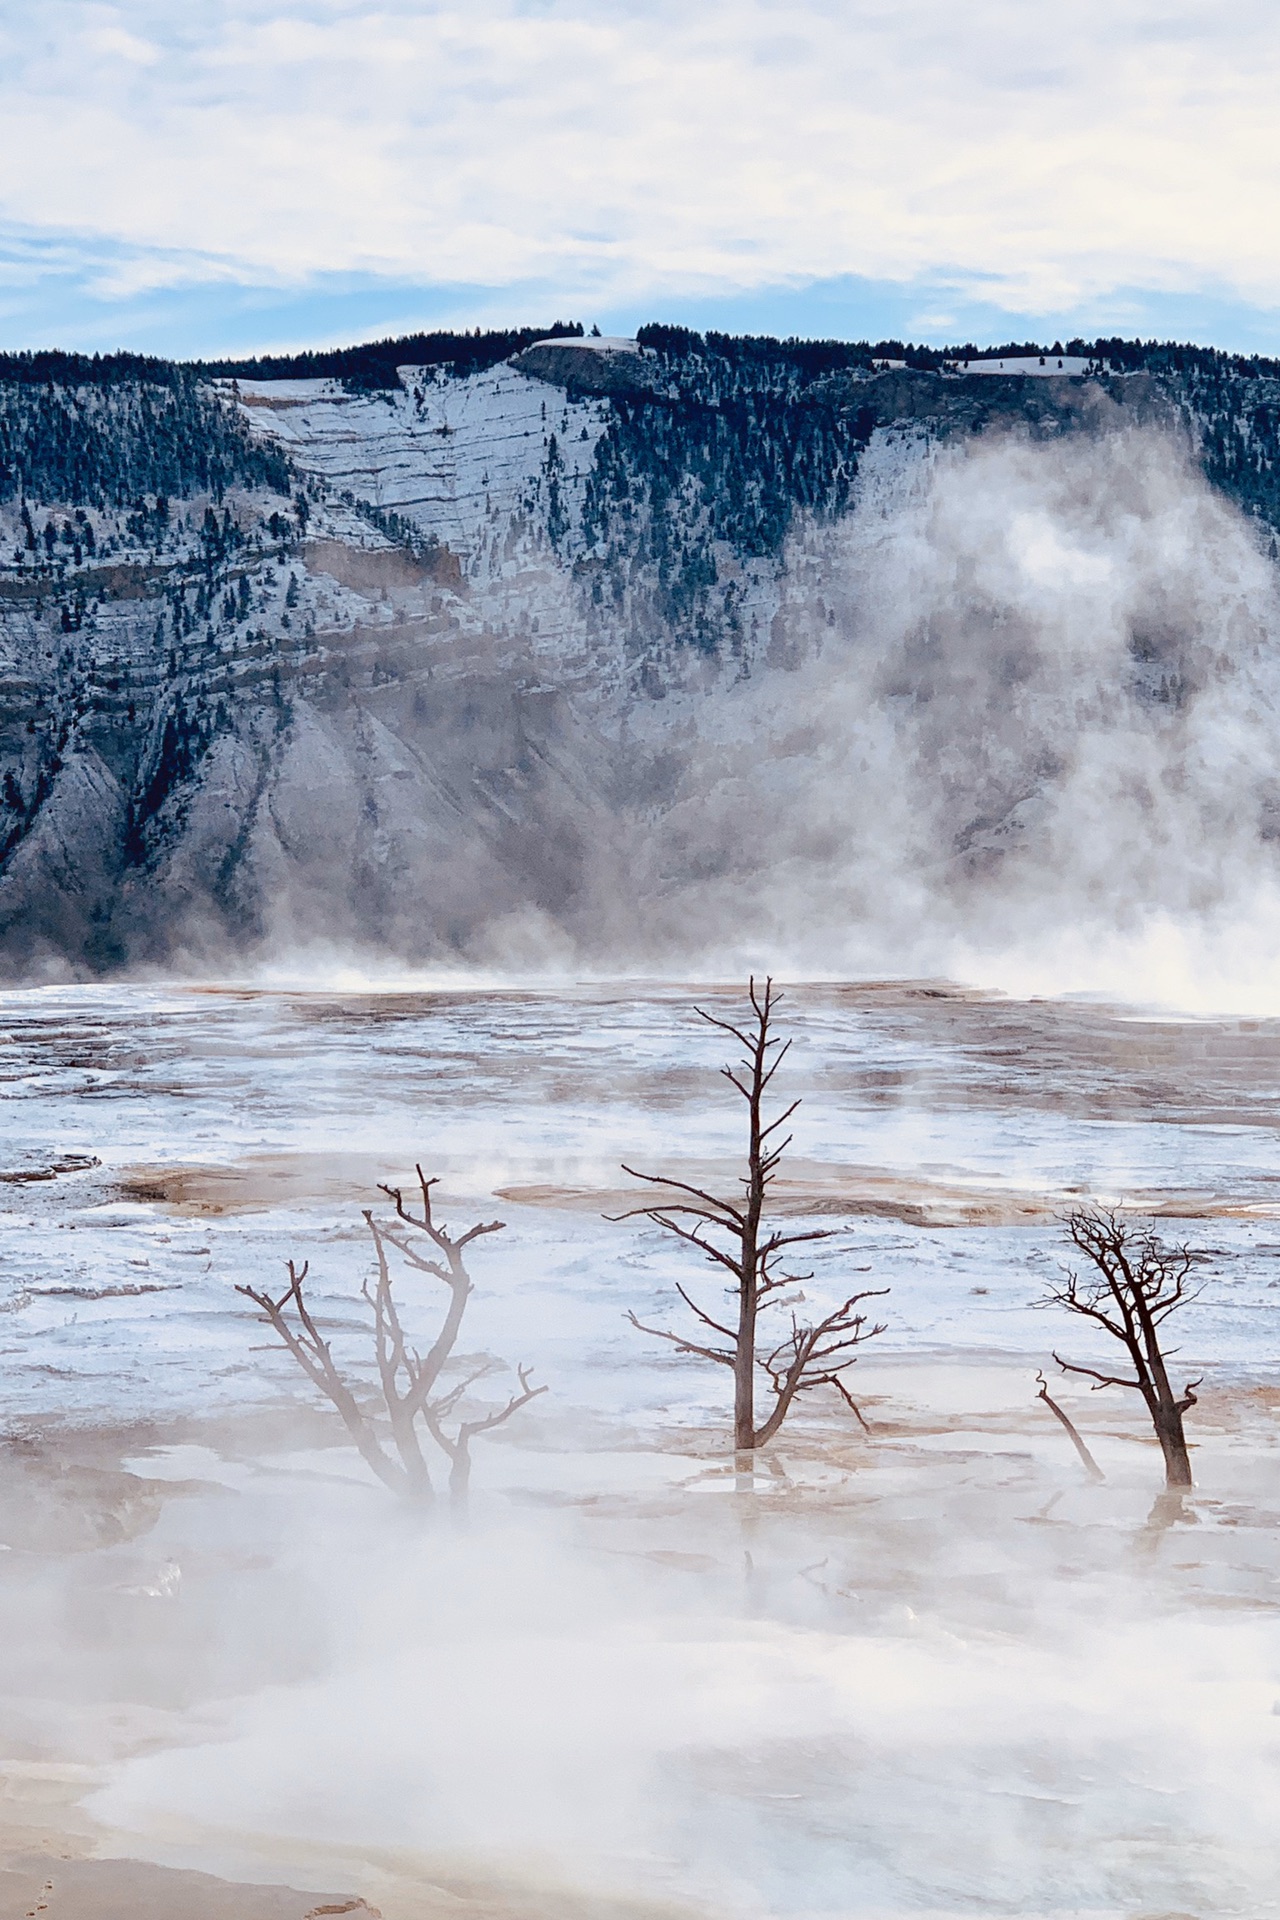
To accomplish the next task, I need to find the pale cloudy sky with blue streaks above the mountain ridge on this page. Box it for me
[0,0,1280,355]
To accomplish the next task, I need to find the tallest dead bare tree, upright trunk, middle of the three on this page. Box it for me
[612,977,889,1453]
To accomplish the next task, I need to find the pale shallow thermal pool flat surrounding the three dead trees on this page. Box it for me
[0,983,1280,1920]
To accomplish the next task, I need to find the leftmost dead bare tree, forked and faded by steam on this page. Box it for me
[236,1167,547,1501]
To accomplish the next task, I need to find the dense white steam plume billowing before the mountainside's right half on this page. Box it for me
[416,428,1280,1006]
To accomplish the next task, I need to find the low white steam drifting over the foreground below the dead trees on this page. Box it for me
[90,1455,1276,1920]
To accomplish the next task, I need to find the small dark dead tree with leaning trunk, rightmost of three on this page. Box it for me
[1044,1208,1207,1488]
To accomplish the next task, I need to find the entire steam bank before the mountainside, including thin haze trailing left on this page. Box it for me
[100,410,1280,1012]
